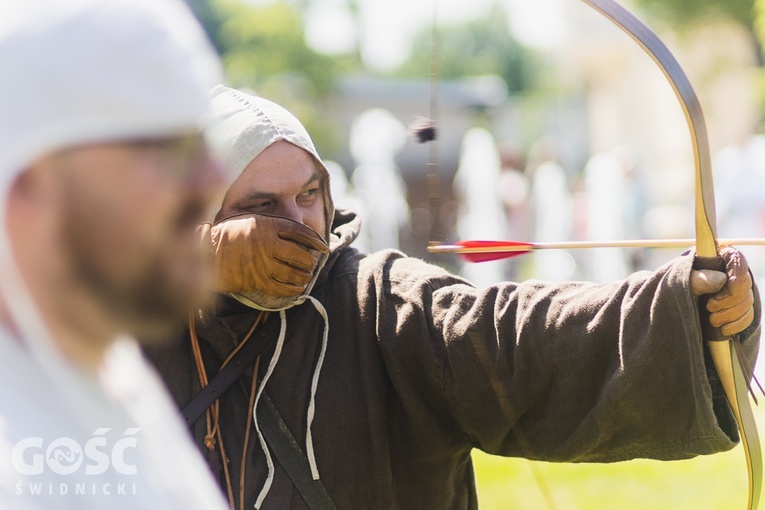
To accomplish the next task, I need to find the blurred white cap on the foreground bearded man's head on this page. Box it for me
[0,0,221,188]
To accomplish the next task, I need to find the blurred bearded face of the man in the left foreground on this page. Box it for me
[51,137,220,338]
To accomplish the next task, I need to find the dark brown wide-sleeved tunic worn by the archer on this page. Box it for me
[145,209,761,509]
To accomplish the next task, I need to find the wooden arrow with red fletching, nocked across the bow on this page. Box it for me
[428,238,765,262]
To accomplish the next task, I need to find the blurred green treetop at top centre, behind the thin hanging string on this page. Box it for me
[394,3,538,92]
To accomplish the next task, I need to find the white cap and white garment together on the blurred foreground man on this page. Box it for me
[0,0,225,510]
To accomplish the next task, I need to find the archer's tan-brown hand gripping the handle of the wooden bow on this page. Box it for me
[691,246,754,337]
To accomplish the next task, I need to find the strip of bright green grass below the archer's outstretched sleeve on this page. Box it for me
[473,404,765,510]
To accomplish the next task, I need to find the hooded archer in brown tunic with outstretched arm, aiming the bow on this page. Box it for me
[153,86,760,509]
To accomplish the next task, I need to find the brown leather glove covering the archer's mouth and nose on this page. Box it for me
[201,214,329,297]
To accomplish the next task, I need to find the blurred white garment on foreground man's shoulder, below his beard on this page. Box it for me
[0,330,227,510]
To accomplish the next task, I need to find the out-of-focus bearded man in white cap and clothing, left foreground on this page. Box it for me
[0,0,230,510]
